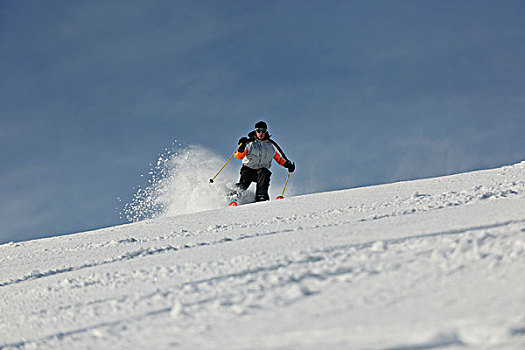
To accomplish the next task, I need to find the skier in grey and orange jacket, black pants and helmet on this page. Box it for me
[230,121,295,202]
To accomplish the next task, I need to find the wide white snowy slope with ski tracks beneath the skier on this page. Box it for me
[0,162,525,349]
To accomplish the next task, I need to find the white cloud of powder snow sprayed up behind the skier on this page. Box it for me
[121,143,254,222]
